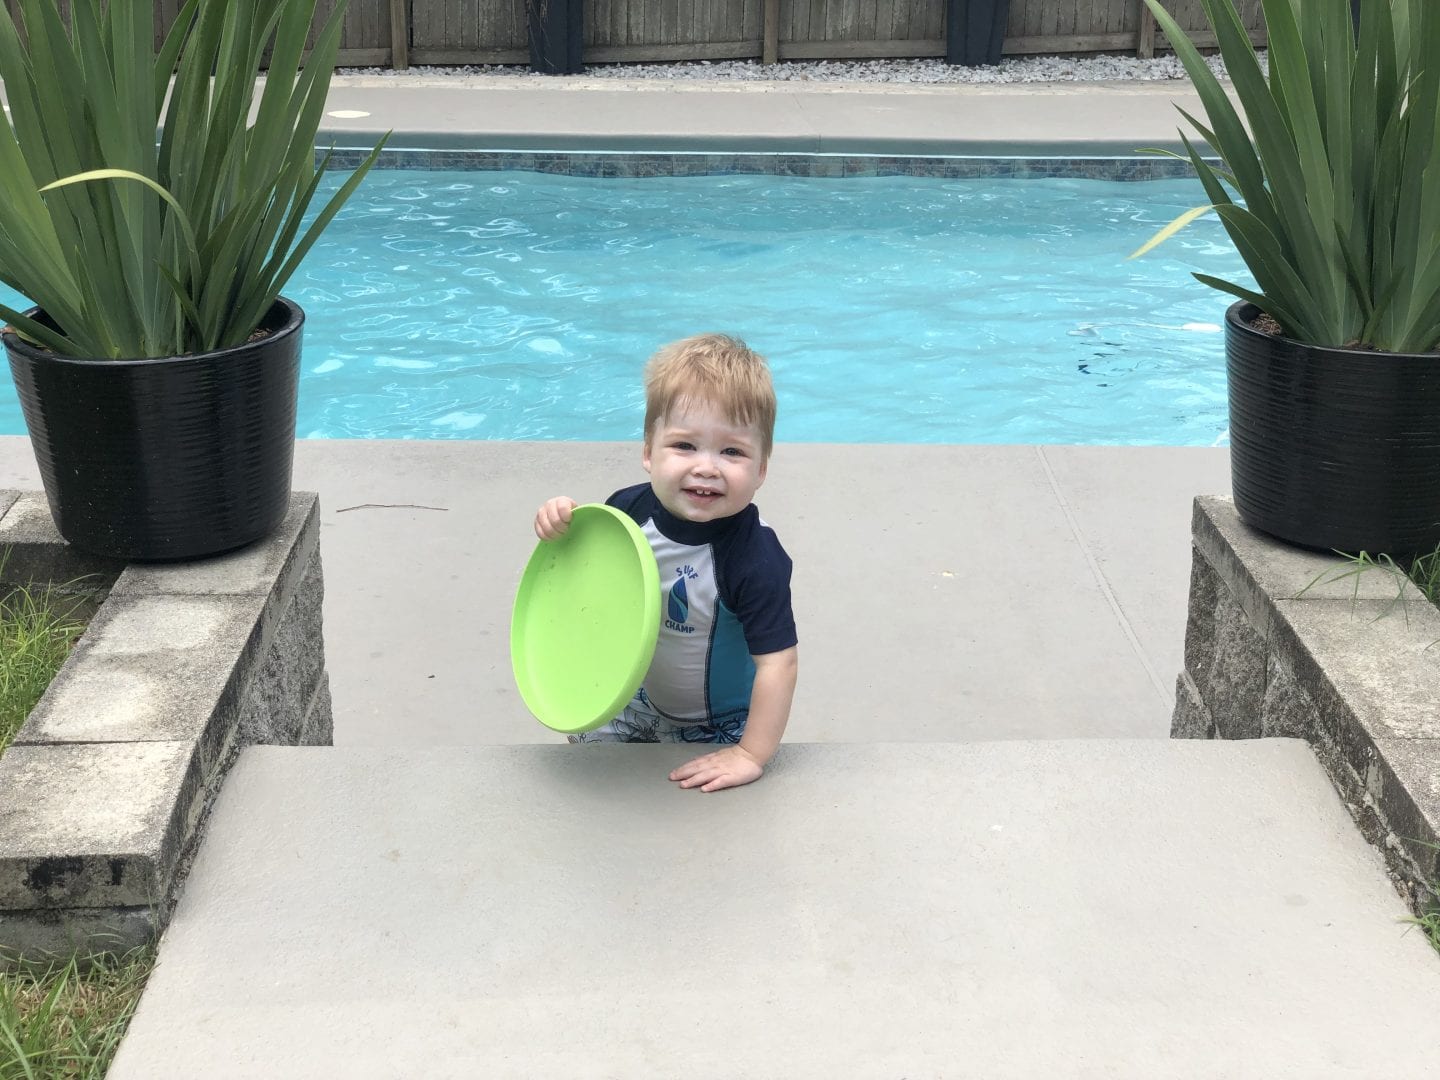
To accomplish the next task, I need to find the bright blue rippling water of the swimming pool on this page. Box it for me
[0,170,1250,445]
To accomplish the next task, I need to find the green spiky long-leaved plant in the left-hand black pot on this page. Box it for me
[0,0,384,359]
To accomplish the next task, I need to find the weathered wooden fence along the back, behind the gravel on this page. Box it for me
[7,0,1266,68]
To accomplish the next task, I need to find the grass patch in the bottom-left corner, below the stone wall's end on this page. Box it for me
[0,945,156,1080]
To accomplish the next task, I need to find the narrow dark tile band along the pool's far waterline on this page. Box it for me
[317,148,1195,180]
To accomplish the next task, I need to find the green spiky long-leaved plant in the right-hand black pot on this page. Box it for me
[1136,0,1440,353]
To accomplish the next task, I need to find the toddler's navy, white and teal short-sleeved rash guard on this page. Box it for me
[606,484,796,723]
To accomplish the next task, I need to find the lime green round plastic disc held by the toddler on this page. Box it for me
[510,503,661,734]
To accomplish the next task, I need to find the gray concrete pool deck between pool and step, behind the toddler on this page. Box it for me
[0,438,1228,746]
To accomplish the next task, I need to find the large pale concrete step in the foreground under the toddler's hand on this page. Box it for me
[109,740,1440,1080]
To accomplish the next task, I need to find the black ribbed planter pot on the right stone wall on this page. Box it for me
[1225,302,1440,559]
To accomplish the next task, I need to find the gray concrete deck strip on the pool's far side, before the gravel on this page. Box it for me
[321,75,1201,156]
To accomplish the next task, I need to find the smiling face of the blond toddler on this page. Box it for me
[642,402,766,521]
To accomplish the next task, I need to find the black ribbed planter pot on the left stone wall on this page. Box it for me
[3,298,305,560]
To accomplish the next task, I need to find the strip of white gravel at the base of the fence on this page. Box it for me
[340,53,1264,85]
